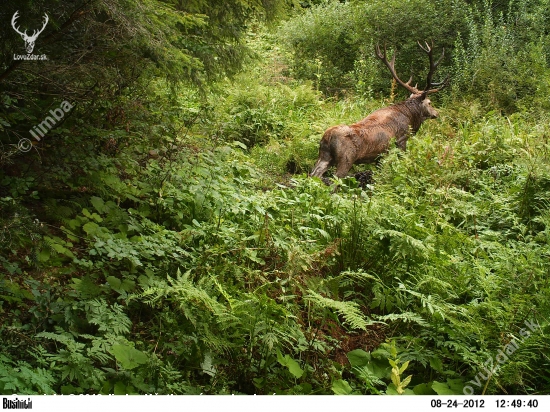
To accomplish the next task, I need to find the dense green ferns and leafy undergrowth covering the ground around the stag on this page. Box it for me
[0,0,550,394]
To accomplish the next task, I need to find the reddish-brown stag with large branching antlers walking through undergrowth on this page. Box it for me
[311,43,448,178]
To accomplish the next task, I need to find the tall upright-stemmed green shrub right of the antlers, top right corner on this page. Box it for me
[453,1,550,112]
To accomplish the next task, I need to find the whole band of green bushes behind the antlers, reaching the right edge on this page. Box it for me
[279,0,550,113]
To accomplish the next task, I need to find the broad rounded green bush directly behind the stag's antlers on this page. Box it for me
[279,1,467,96]
